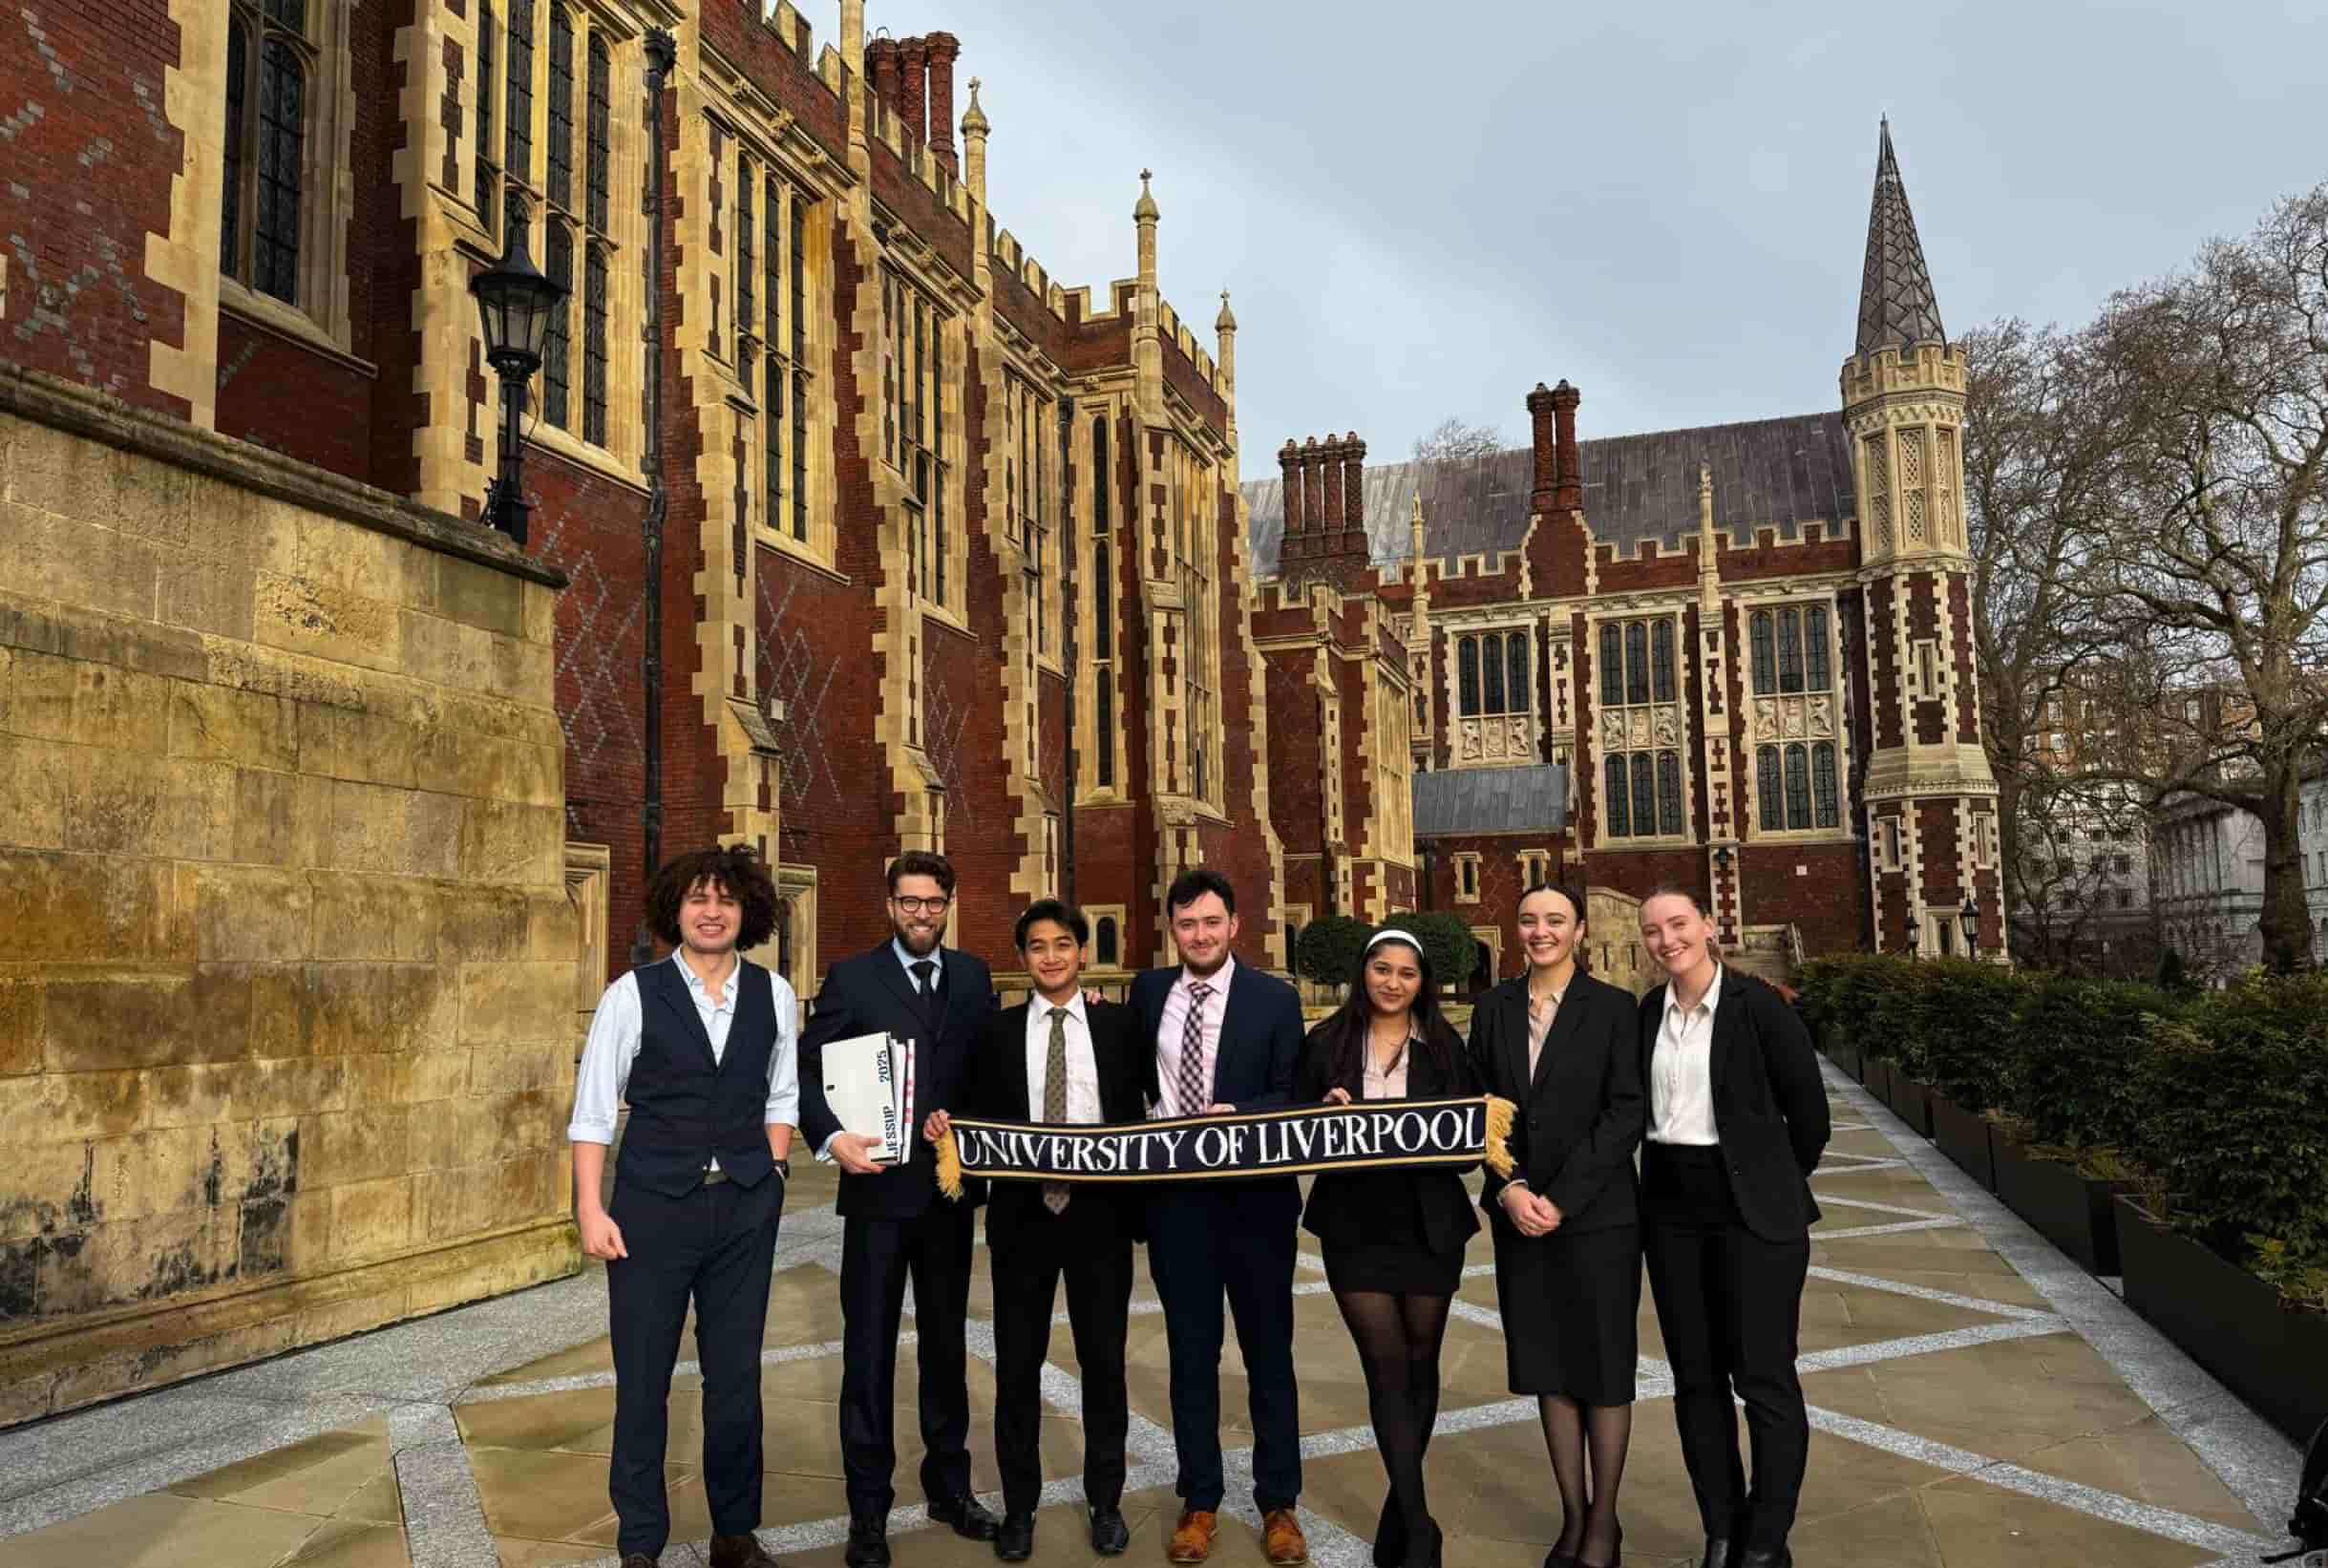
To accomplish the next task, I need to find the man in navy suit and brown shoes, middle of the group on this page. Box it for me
[1129,868,1308,1563]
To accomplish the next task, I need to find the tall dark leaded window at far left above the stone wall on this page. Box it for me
[219,0,321,305]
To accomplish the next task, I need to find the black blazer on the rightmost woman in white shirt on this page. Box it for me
[1641,965,1828,1242]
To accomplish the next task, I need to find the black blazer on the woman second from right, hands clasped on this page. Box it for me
[1471,972,1648,1236]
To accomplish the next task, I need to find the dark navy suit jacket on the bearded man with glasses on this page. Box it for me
[801,943,994,1219]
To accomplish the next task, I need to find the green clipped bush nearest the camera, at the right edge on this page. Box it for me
[2123,975,2328,1265]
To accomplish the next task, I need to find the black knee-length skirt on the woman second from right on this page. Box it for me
[1494,1223,1641,1405]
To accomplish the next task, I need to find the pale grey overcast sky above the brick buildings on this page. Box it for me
[815,0,2328,477]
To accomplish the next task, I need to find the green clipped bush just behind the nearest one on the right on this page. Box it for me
[2004,977,2184,1163]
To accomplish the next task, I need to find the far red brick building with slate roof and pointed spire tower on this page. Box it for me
[1243,128,2004,977]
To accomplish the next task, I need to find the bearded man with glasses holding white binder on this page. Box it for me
[801,849,1001,1568]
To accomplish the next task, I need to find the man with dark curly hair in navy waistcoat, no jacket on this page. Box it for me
[565,844,801,1568]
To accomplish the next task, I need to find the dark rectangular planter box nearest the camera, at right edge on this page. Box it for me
[2119,1198,2328,1442]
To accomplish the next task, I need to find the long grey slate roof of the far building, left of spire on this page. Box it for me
[1240,412,1858,577]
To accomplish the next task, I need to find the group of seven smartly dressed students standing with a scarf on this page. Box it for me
[568,847,1828,1568]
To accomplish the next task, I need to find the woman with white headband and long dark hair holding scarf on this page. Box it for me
[1295,926,1478,1568]
